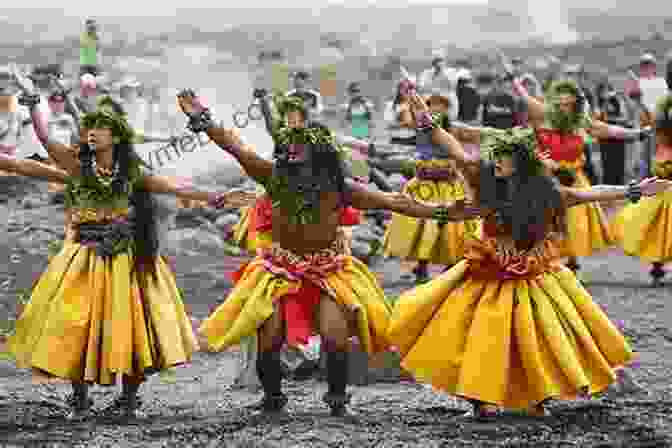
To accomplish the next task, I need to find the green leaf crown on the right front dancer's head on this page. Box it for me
[481,127,544,174]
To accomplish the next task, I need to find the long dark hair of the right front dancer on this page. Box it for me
[479,151,566,249]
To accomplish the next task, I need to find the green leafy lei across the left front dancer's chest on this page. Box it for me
[64,161,141,208]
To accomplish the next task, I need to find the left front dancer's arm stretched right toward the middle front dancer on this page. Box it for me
[142,175,257,208]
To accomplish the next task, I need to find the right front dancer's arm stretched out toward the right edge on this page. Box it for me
[560,177,672,207]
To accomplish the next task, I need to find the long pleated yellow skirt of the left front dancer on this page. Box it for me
[8,240,198,385]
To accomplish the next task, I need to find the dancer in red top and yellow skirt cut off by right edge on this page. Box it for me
[612,95,672,286]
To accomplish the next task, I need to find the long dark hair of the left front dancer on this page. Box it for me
[79,107,159,278]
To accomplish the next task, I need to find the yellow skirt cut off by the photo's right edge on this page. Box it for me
[611,191,672,263]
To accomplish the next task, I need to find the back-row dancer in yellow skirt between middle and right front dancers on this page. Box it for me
[384,95,479,283]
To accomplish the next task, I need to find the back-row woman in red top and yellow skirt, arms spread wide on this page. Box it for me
[505,73,648,272]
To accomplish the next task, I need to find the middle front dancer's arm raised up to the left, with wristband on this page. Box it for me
[178,90,273,181]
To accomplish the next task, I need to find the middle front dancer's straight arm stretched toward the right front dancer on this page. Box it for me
[348,181,480,222]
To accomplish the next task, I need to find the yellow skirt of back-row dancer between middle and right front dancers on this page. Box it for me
[384,178,480,266]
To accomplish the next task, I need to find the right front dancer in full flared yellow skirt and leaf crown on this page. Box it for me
[388,93,672,418]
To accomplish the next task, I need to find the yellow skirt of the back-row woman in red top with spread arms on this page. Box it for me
[561,170,614,257]
